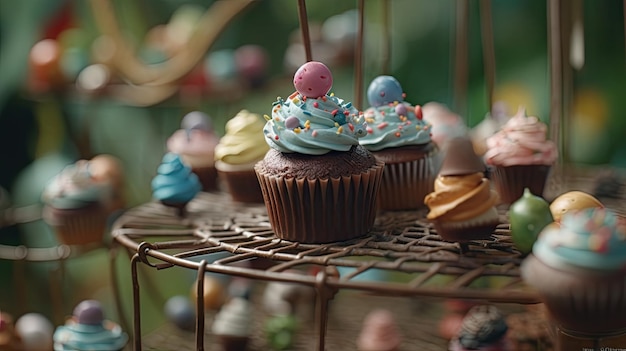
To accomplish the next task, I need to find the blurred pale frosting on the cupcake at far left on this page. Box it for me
[42,160,113,209]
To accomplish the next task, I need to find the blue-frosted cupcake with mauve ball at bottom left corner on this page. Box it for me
[53,300,128,351]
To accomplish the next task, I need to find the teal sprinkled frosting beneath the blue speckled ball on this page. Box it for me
[359,102,431,151]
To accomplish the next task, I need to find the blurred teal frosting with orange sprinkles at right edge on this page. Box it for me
[533,208,626,271]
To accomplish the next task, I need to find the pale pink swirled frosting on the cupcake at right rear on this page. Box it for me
[485,108,558,167]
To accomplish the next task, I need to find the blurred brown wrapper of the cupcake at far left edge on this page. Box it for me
[43,203,108,245]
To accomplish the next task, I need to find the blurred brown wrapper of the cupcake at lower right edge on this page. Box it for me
[521,254,626,335]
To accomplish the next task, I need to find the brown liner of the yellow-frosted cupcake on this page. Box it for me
[218,169,263,203]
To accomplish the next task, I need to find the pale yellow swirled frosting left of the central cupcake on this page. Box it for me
[215,110,269,165]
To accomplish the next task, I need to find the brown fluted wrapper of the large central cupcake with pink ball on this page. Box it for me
[255,162,384,243]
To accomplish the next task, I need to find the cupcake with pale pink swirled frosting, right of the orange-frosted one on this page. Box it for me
[485,108,558,204]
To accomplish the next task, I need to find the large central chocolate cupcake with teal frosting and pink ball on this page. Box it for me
[255,62,384,243]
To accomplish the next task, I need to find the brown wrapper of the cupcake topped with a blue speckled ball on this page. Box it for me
[378,156,436,210]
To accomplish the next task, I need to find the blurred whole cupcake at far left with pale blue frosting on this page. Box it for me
[42,155,124,245]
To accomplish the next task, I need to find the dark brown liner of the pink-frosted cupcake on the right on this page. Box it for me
[490,165,551,204]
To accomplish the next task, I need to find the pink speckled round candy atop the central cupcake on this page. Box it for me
[293,61,333,99]
